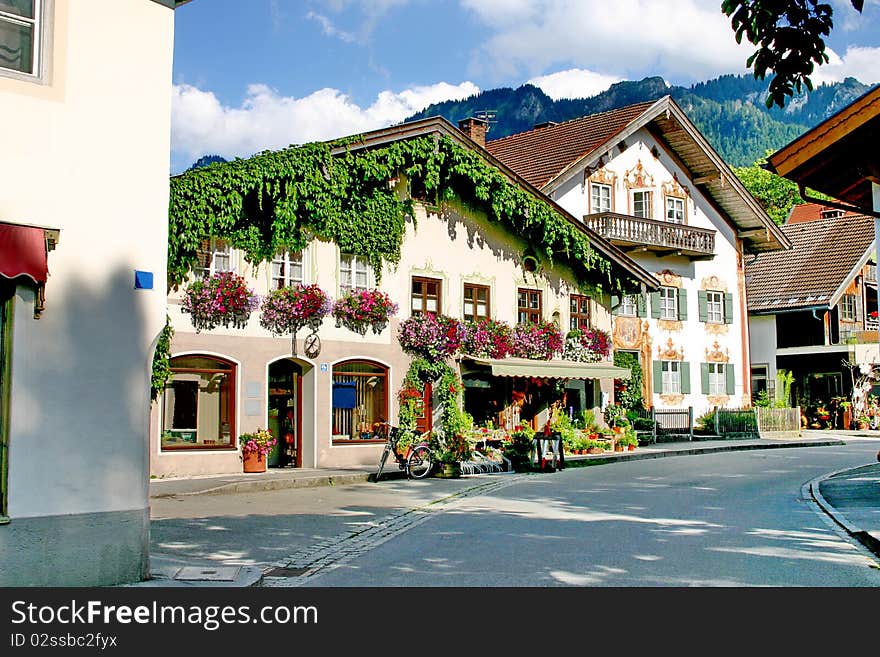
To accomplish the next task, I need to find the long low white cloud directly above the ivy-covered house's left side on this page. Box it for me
[171,82,480,168]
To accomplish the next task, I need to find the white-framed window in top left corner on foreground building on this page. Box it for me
[0,0,44,76]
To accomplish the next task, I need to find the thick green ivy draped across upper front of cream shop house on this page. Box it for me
[168,136,637,293]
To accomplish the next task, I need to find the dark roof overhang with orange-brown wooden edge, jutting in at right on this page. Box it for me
[765,80,880,214]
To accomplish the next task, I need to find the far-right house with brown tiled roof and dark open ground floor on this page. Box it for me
[746,215,878,405]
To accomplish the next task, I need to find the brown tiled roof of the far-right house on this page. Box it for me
[746,215,874,312]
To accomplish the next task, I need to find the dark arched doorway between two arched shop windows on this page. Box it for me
[267,358,303,468]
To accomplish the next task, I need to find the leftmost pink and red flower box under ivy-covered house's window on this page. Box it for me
[182,271,260,333]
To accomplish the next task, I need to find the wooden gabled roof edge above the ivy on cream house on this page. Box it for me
[334,116,658,290]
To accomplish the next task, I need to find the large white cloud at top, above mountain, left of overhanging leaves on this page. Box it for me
[459,0,753,81]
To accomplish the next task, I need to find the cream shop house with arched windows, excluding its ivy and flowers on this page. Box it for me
[150,118,653,476]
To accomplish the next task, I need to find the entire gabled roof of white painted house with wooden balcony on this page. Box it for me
[486,96,790,253]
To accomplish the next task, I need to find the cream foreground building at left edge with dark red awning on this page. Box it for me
[0,0,175,586]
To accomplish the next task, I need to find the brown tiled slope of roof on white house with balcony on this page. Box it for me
[486,101,655,189]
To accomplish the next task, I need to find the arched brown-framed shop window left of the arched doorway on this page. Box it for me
[162,355,236,450]
